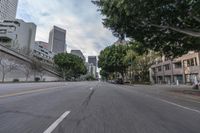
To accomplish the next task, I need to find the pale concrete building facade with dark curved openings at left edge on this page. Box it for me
[0,19,36,55]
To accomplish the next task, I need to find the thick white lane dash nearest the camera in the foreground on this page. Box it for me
[43,111,70,133]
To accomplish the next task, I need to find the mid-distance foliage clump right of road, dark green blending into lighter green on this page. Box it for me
[98,42,160,82]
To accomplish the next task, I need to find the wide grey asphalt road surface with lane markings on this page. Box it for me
[0,82,200,133]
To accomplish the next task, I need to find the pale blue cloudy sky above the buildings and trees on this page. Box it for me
[17,0,117,56]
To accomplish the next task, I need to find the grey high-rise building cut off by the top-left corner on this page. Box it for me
[0,0,18,21]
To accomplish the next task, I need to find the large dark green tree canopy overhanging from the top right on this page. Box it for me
[93,0,200,56]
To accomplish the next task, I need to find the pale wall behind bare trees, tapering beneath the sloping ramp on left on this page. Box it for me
[0,50,62,82]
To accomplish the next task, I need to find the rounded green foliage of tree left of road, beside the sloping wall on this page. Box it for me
[54,53,87,80]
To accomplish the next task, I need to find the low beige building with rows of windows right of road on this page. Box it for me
[150,52,200,84]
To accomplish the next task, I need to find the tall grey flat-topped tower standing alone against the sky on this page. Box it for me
[48,26,66,54]
